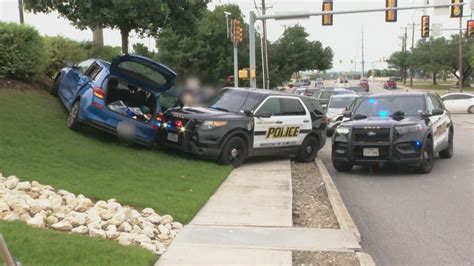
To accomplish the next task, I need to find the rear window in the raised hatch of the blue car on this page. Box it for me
[118,61,166,87]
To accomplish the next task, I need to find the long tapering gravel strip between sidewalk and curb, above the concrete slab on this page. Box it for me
[291,161,340,229]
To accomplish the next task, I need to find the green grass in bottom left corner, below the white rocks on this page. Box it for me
[0,221,156,266]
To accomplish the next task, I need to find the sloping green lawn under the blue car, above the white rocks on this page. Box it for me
[0,88,231,223]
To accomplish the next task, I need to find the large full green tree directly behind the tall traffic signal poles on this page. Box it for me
[157,4,261,85]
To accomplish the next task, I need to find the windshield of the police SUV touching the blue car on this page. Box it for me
[205,89,263,113]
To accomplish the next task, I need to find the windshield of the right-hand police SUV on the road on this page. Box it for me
[353,95,424,117]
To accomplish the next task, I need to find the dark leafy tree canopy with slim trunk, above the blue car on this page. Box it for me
[25,0,208,53]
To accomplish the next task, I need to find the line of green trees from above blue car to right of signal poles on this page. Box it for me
[24,0,333,87]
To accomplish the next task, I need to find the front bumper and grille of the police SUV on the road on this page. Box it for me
[332,129,423,166]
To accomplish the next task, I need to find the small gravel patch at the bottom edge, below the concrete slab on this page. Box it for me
[293,251,360,266]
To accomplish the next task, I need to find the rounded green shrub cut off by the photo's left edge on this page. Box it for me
[0,22,45,79]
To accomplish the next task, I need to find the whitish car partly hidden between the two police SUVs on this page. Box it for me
[326,94,361,136]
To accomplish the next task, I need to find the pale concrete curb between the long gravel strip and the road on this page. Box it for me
[315,157,362,243]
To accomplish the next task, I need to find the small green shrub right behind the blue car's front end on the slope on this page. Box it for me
[44,36,87,77]
